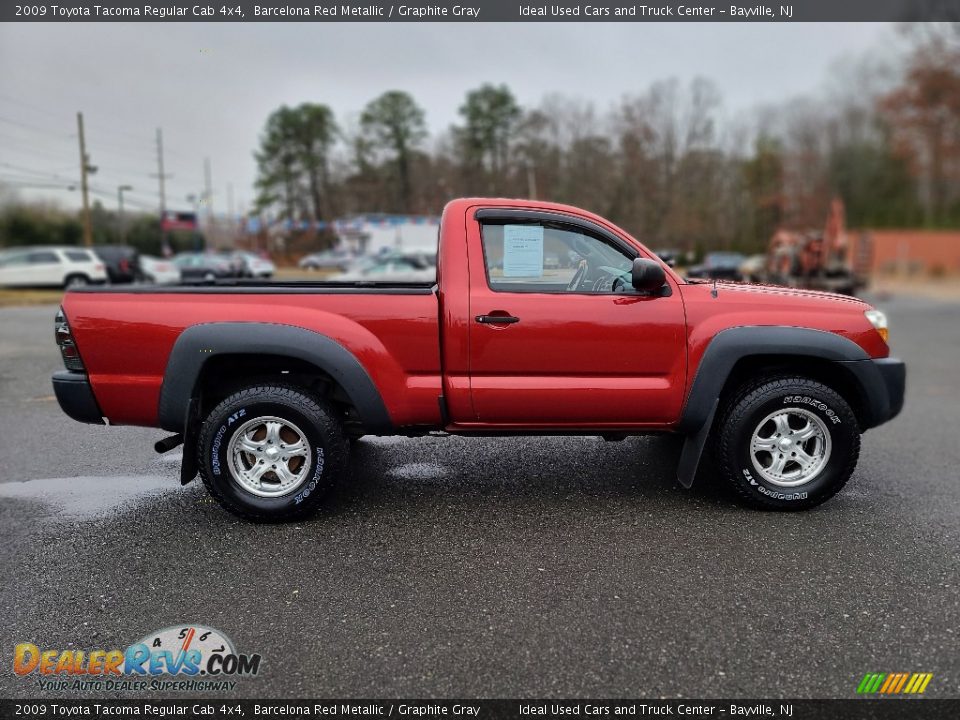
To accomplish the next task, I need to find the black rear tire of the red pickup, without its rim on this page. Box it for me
[197,384,349,522]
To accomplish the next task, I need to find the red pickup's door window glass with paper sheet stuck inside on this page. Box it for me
[481,223,633,293]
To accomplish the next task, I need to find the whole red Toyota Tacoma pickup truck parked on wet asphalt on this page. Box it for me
[53,199,905,520]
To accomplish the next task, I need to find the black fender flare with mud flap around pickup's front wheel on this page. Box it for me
[677,325,878,488]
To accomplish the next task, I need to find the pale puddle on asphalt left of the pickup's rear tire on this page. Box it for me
[0,475,182,520]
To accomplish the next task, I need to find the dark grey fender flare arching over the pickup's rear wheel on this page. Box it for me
[157,322,394,435]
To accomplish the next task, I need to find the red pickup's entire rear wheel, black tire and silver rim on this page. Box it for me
[197,385,349,521]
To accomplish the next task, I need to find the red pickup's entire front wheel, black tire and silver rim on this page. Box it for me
[716,377,860,510]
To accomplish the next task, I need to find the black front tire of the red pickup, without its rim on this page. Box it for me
[713,376,860,510]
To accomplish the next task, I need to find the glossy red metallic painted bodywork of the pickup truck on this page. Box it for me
[64,198,889,432]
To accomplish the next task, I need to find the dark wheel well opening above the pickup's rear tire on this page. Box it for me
[193,353,363,437]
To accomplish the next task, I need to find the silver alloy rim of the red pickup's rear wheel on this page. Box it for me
[228,416,311,497]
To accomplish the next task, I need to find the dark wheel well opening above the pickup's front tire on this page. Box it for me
[720,355,868,427]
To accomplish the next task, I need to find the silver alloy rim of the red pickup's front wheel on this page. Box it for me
[750,408,831,487]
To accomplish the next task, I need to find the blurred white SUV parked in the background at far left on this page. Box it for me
[0,246,107,287]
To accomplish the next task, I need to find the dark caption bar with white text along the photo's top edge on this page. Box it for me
[0,0,960,23]
